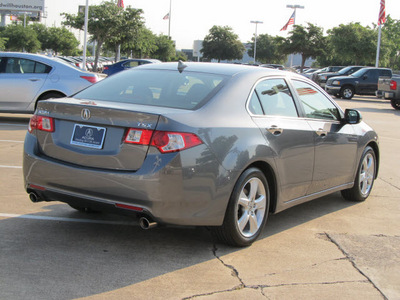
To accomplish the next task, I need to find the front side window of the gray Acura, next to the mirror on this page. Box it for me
[292,80,340,120]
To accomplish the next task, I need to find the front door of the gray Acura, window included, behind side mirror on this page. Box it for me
[292,80,357,195]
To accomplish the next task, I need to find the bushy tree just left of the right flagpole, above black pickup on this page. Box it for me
[327,23,378,66]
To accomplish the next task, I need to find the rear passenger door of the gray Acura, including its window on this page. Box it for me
[248,78,314,202]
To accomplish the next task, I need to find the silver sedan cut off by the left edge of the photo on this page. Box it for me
[0,52,97,113]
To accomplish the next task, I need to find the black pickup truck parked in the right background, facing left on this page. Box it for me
[325,67,392,99]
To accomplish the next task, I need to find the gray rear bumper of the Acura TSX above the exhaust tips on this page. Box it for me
[23,134,233,226]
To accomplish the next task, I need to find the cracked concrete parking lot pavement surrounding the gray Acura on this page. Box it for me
[0,97,400,299]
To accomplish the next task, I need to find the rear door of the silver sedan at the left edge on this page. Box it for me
[0,57,51,111]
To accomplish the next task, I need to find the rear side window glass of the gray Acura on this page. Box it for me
[253,79,298,117]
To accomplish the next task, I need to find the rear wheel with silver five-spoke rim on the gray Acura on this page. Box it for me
[214,168,270,247]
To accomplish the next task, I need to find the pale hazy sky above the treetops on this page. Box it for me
[43,0,400,49]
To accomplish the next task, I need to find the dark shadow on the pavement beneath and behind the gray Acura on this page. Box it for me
[0,193,354,299]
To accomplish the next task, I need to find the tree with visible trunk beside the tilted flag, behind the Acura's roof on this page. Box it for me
[281,23,326,71]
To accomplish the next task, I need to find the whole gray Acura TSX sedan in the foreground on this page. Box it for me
[23,63,379,246]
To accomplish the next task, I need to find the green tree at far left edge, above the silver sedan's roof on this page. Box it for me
[2,24,41,52]
